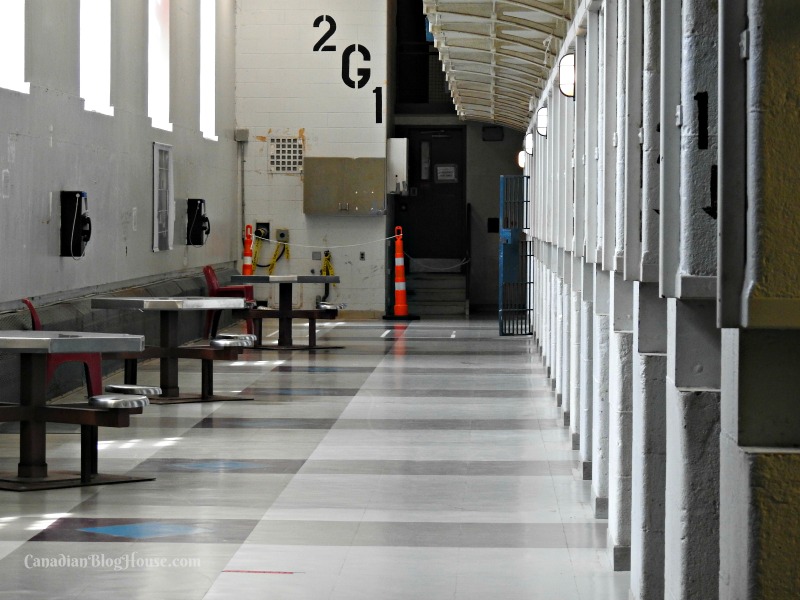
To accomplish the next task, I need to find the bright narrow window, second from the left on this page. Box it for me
[80,0,114,115]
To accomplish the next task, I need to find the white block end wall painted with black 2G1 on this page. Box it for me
[236,0,393,313]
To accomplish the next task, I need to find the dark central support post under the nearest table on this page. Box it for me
[17,354,47,477]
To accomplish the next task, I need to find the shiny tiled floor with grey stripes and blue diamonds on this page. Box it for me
[0,319,629,600]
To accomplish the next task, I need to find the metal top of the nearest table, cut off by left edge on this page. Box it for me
[0,330,144,354]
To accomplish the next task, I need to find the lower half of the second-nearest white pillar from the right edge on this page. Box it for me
[664,298,720,600]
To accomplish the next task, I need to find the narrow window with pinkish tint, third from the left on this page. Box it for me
[147,0,172,131]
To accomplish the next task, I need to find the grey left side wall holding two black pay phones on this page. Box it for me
[0,0,240,308]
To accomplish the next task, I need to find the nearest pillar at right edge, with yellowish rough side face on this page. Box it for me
[719,0,800,599]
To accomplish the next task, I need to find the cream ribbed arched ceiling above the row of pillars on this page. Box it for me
[422,0,575,131]
